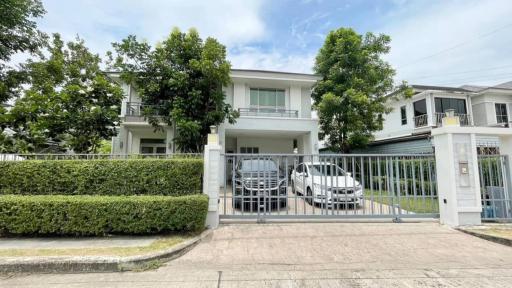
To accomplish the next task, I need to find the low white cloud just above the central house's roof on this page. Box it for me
[228,47,316,73]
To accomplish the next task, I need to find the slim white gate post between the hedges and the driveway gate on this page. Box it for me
[203,126,223,229]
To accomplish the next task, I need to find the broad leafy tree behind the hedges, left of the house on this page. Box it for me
[6,34,123,153]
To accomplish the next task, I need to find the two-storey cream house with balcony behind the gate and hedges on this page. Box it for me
[110,69,318,154]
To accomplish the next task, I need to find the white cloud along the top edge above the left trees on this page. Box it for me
[39,0,265,53]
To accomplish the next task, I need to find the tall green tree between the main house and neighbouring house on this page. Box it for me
[312,28,410,153]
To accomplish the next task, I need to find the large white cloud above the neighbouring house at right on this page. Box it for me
[380,0,512,86]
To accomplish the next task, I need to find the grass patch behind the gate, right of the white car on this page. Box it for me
[364,190,439,214]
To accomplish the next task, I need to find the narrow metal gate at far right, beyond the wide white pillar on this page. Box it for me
[478,155,512,221]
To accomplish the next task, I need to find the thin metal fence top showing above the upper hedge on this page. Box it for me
[0,153,203,161]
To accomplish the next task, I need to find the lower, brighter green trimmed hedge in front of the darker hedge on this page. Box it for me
[0,194,208,236]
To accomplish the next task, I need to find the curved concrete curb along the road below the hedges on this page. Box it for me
[0,229,213,273]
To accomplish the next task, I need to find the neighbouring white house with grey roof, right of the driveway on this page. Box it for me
[365,82,512,153]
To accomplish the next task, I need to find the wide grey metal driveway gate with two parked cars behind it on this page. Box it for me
[220,154,439,221]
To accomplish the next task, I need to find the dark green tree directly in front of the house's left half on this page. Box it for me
[111,28,238,152]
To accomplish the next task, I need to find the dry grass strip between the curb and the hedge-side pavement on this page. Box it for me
[0,232,200,257]
